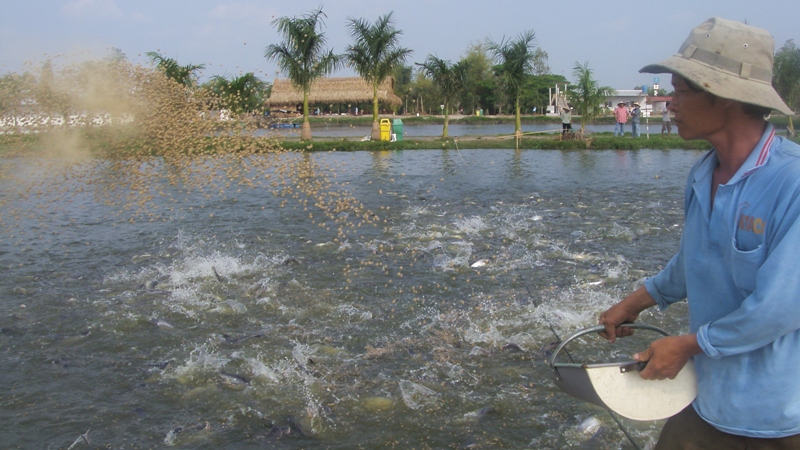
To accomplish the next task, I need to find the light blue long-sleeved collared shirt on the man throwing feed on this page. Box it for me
[645,124,800,438]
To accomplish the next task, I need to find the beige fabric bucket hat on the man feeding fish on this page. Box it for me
[639,17,794,115]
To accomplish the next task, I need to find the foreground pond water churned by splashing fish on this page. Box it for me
[0,150,700,449]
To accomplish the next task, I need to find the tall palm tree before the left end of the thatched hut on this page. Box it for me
[264,7,341,141]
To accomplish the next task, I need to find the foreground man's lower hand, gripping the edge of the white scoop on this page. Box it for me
[633,334,702,380]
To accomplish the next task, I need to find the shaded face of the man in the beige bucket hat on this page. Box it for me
[669,74,725,140]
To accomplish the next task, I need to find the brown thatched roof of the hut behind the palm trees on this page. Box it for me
[267,77,403,110]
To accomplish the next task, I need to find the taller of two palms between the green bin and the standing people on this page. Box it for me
[487,30,537,136]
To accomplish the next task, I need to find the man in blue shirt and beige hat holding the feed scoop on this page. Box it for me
[599,18,800,450]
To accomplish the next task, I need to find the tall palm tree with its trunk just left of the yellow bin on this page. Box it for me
[345,12,411,139]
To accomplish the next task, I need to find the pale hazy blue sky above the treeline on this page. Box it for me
[0,0,800,89]
